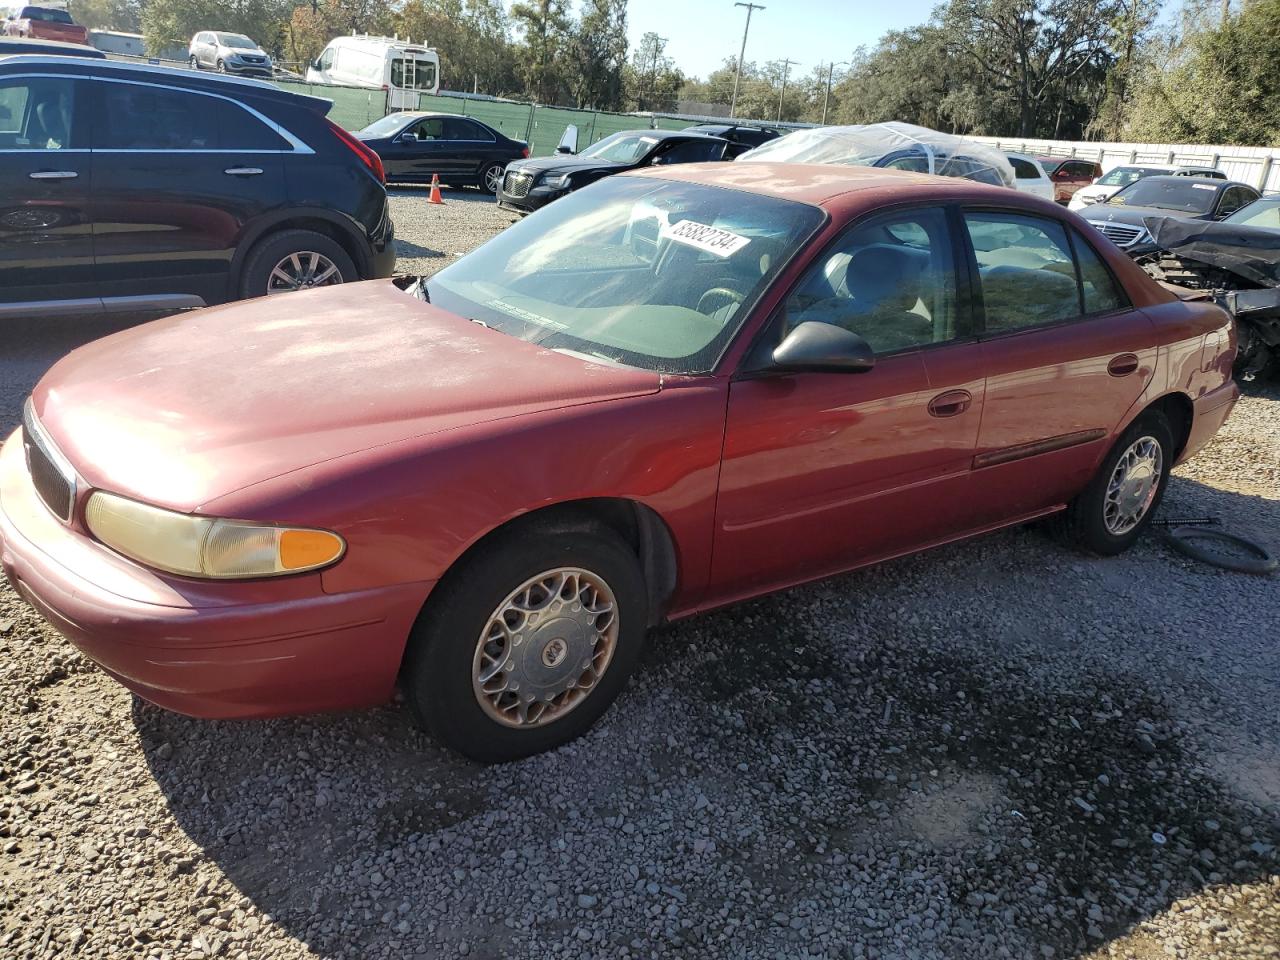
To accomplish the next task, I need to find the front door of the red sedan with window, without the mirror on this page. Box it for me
[709,209,983,603]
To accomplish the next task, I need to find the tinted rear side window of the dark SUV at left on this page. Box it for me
[93,83,289,150]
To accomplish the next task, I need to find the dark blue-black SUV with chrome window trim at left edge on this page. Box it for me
[0,56,396,317]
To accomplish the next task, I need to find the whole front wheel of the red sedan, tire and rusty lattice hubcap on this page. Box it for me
[402,527,648,763]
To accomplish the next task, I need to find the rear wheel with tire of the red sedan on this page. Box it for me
[1061,410,1174,557]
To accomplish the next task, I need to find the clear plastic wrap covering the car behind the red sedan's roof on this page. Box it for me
[737,122,1014,188]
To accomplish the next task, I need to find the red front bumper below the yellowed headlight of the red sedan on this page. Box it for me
[0,434,431,718]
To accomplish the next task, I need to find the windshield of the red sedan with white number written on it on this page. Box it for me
[425,177,823,374]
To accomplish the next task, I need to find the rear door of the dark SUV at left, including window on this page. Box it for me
[92,81,292,303]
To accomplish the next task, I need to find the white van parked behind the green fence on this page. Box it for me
[307,36,440,110]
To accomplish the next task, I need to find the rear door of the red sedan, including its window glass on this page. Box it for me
[964,210,1156,522]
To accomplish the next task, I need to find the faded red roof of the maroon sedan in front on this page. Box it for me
[621,161,1048,206]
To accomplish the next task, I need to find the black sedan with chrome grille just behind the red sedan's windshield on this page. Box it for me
[498,131,730,214]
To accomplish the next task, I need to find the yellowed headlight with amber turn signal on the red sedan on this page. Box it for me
[84,490,347,580]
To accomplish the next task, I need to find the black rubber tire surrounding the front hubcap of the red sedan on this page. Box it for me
[401,525,648,763]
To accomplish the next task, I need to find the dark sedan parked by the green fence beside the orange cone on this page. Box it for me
[356,113,529,193]
